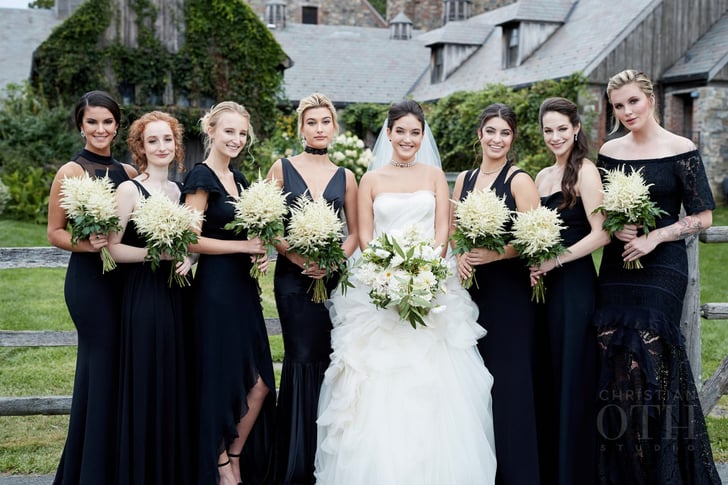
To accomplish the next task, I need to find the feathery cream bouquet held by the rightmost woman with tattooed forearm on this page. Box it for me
[594,166,667,269]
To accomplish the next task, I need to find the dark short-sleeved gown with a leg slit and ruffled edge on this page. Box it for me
[182,163,276,485]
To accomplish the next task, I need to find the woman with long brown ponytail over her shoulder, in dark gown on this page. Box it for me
[531,98,609,485]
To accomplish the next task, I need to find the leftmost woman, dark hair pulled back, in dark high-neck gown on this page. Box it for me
[48,91,137,485]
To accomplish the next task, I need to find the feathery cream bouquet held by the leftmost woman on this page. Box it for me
[60,172,121,273]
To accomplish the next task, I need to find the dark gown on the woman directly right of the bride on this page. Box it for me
[461,163,539,485]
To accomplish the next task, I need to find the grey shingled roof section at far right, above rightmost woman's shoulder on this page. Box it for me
[662,14,728,82]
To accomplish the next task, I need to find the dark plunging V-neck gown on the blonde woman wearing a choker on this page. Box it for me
[274,158,346,485]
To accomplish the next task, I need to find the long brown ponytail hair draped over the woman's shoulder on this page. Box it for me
[538,98,589,209]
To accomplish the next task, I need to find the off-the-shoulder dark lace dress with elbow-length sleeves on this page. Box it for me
[594,151,720,485]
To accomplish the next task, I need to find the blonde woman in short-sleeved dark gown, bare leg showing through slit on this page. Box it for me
[182,101,275,485]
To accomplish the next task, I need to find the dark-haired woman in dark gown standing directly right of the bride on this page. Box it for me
[452,104,539,485]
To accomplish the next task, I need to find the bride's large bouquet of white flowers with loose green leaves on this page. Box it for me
[356,227,450,328]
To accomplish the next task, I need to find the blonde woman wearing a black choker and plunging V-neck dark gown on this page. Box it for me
[268,93,357,485]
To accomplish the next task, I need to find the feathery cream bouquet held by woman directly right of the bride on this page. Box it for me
[452,190,511,288]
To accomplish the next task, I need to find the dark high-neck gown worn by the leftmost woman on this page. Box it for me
[53,149,129,485]
